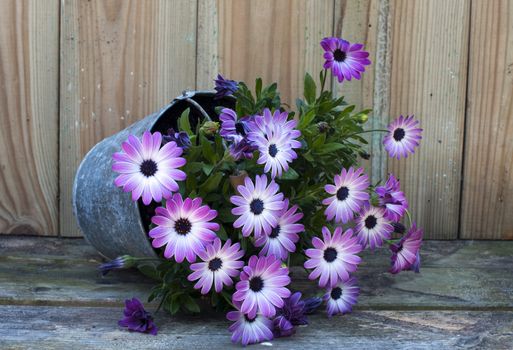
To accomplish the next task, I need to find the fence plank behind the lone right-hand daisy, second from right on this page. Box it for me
[388,0,470,239]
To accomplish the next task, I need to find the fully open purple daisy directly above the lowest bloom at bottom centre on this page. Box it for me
[232,255,290,318]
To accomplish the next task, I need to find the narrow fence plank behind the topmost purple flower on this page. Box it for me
[333,0,390,183]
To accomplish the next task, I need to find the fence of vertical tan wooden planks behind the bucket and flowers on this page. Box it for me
[0,0,513,239]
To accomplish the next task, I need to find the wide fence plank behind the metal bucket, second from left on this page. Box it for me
[60,0,197,236]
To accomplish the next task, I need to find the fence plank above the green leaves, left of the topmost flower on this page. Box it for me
[211,0,333,106]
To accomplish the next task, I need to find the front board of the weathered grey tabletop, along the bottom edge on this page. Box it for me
[0,306,513,350]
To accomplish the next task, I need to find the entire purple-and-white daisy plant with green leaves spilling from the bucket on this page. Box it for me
[109,38,423,345]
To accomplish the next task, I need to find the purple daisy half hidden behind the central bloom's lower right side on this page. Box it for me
[255,199,305,260]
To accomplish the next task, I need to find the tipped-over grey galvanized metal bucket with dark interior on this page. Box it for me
[73,91,234,259]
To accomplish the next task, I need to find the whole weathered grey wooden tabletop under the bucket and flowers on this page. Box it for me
[0,237,513,349]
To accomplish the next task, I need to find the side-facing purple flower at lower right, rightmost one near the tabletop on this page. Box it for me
[390,223,424,274]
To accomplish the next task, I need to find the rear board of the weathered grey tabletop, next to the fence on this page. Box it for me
[0,237,513,311]
